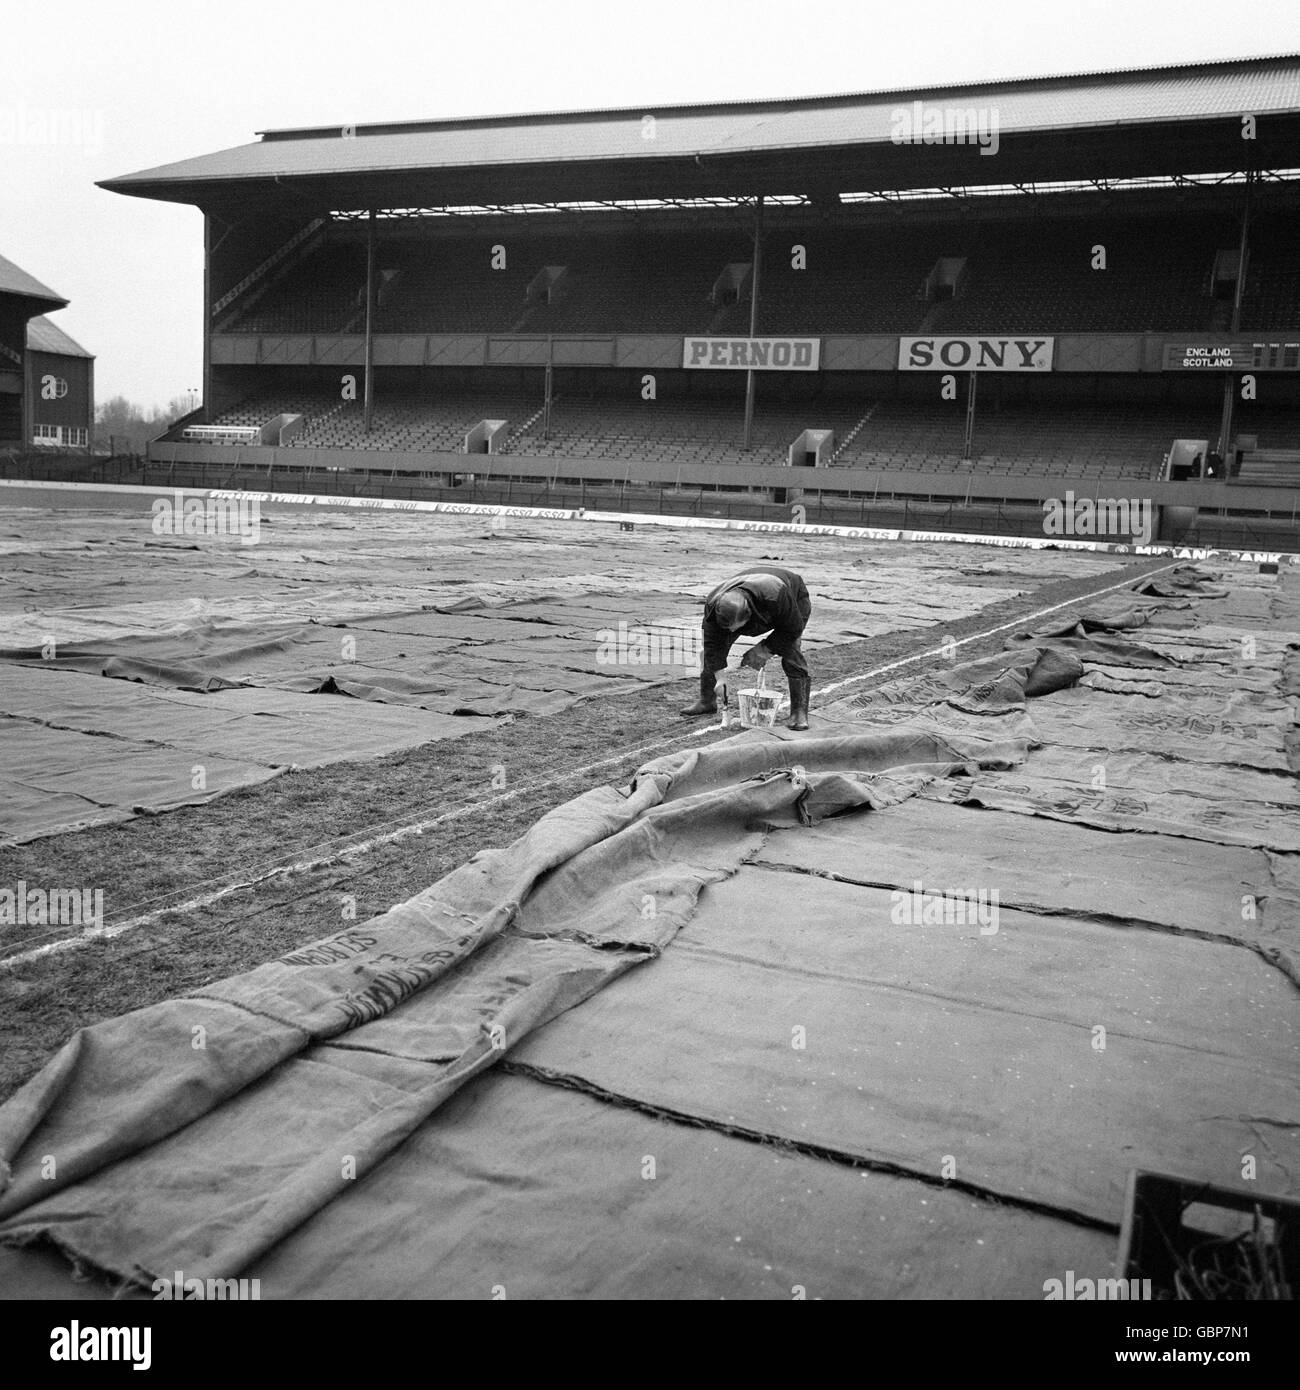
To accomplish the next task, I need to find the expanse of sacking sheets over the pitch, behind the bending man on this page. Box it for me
[0,505,1105,844]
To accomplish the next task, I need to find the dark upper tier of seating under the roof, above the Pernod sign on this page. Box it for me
[229,217,1300,334]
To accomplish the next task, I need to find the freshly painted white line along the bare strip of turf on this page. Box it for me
[0,560,1183,969]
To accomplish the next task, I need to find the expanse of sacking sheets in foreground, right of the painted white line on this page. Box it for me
[0,558,1300,1297]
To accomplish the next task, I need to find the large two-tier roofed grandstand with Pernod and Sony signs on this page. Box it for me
[0,57,1284,548]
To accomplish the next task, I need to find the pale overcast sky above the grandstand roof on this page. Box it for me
[0,0,1300,406]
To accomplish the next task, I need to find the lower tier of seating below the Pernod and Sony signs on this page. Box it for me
[198,392,1300,482]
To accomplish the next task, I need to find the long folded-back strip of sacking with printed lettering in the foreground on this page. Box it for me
[0,727,1026,1284]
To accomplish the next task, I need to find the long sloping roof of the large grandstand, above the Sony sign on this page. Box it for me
[100,54,1300,214]
